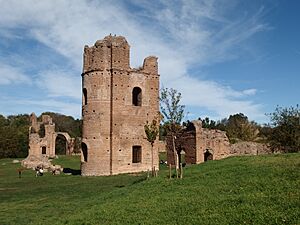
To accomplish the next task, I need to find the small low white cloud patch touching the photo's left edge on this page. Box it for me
[0,62,31,85]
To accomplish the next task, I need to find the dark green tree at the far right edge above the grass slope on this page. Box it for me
[268,105,300,152]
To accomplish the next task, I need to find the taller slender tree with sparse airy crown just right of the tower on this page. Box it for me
[160,88,185,177]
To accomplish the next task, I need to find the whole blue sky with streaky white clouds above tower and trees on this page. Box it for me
[0,0,300,123]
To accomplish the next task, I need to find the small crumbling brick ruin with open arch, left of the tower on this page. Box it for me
[22,113,75,168]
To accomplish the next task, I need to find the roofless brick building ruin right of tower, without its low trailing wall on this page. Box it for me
[166,120,230,165]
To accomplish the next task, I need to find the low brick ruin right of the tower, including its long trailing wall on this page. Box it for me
[166,120,271,165]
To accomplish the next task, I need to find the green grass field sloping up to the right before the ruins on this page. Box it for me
[0,153,300,225]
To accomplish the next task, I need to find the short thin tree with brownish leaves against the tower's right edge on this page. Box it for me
[144,119,159,176]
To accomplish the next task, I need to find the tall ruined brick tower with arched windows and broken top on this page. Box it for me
[81,35,159,176]
